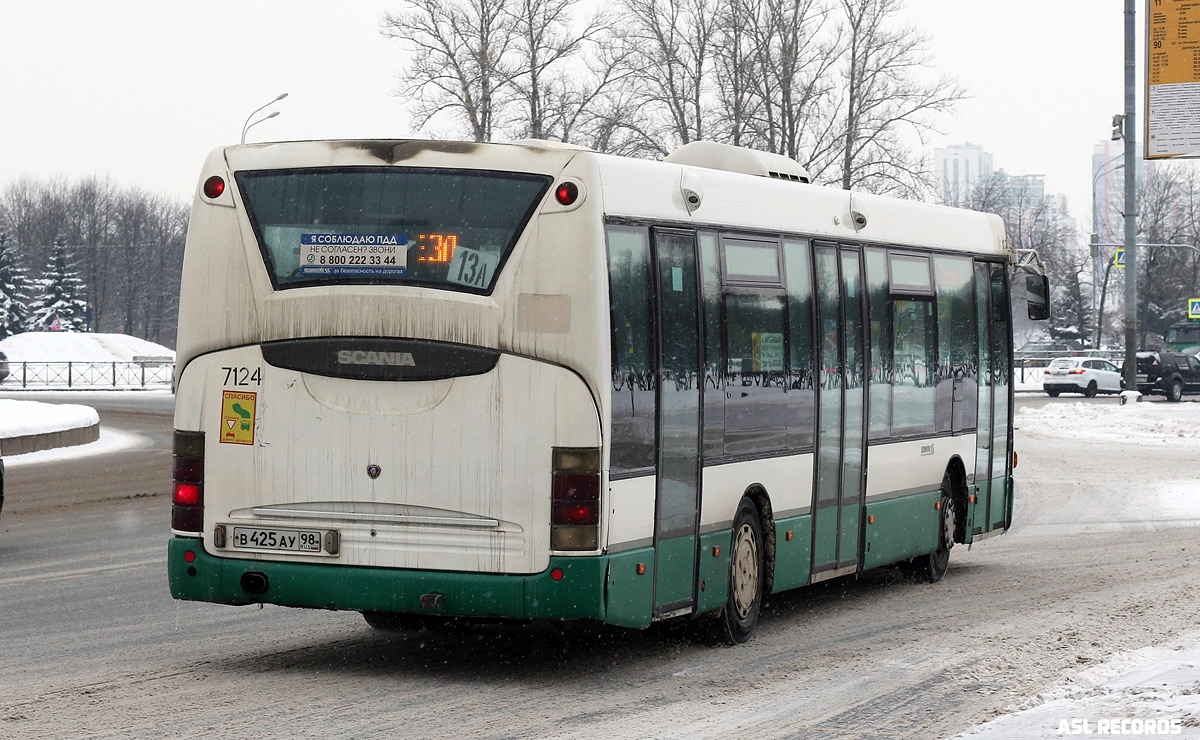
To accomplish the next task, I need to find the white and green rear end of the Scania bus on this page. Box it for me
[168,142,607,619]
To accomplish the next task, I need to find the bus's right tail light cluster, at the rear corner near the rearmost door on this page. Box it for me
[550,447,600,551]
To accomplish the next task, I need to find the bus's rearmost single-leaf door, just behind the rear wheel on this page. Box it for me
[654,229,703,616]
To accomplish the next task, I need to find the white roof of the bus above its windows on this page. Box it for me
[210,139,1015,261]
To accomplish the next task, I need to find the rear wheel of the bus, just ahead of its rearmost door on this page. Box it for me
[716,497,766,645]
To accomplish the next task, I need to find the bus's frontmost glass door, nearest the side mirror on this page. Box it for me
[967,263,1012,541]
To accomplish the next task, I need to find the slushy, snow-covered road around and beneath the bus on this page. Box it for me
[0,399,1200,740]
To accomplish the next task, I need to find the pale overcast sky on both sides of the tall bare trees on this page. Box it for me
[0,0,1145,229]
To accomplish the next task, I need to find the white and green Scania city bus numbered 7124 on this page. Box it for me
[168,140,1048,643]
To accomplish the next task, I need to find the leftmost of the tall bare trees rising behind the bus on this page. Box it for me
[380,0,520,142]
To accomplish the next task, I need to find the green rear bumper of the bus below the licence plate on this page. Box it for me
[167,537,608,620]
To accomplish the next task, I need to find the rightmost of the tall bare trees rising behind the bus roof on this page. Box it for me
[835,0,966,195]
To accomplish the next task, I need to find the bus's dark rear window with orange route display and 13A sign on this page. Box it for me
[236,167,551,293]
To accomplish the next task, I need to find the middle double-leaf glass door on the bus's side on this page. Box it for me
[812,243,866,582]
